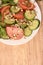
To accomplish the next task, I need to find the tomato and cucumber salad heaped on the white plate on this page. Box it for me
[0,0,40,40]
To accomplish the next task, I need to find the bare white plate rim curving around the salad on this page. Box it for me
[0,2,41,45]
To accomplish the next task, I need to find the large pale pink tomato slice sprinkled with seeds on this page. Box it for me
[6,26,24,40]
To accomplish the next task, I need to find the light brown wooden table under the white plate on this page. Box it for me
[0,1,43,65]
